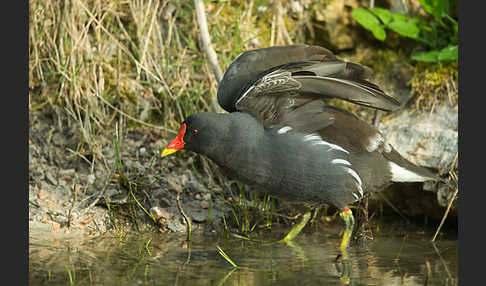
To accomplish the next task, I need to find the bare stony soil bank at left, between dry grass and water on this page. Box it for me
[29,109,231,239]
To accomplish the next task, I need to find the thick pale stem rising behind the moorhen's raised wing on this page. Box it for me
[194,0,223,82]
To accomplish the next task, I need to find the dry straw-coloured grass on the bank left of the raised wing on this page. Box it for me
[29,0,306,163]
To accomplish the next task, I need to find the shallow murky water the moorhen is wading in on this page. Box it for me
[29,225,458,285]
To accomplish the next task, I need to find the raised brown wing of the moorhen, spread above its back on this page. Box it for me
[218,46,400,131]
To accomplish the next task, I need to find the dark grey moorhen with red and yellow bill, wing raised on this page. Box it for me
[161,45,440,251]
